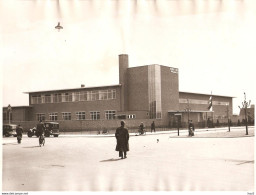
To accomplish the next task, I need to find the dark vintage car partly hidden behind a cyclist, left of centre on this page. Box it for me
[27,122,60,137]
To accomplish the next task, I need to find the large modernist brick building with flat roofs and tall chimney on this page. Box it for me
[3,54,233,130]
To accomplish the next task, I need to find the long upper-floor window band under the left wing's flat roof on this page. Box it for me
[31,89,116,104]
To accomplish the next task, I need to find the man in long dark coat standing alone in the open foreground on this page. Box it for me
[115,121,129,159]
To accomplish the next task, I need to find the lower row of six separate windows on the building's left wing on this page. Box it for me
[36,110,116,121]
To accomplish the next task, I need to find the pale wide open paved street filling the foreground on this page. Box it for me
[2,127,254,192]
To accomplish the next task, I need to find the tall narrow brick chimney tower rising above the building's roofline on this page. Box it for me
[119,54,129,112]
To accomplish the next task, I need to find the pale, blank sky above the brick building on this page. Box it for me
[0,0,256,114]
